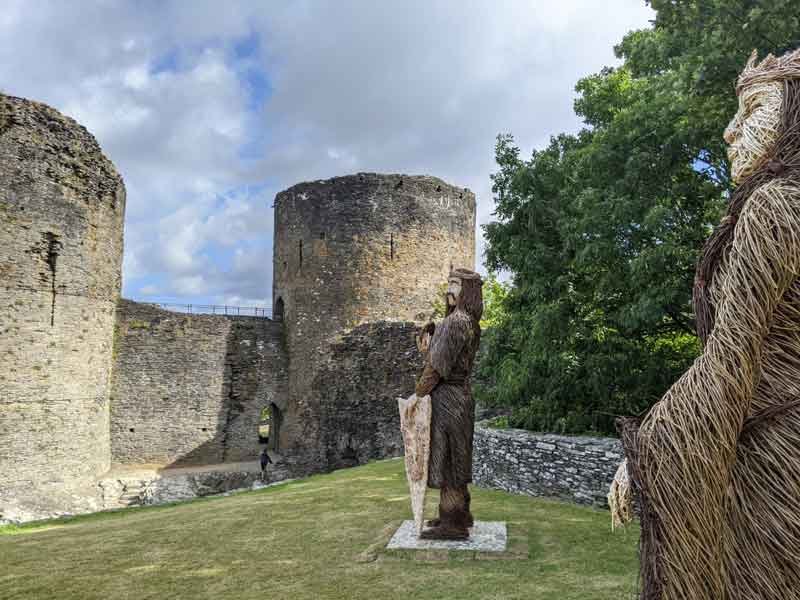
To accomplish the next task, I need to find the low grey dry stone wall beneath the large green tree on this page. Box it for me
[472,425,622,507]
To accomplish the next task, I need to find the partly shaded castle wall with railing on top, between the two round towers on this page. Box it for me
[111,300,286,465]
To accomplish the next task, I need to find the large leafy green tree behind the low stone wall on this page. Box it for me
[477,0,800,432]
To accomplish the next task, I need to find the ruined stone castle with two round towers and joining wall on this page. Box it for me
[0,94,475,519]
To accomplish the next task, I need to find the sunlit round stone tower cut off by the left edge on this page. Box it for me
[0,94,125,509]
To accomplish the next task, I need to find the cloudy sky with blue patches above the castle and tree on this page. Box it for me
[0,0,653,306]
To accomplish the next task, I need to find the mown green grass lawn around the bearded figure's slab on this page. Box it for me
[0,460,638,600]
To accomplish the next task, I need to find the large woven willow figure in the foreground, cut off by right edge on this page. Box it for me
[609,50,800,600]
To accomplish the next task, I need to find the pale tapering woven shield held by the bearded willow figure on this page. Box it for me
[397,394,431,535]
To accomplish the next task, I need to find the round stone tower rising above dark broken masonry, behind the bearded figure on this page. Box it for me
[272,173,475,470]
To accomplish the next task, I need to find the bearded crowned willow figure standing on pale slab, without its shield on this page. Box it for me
[415,269,483,540]
